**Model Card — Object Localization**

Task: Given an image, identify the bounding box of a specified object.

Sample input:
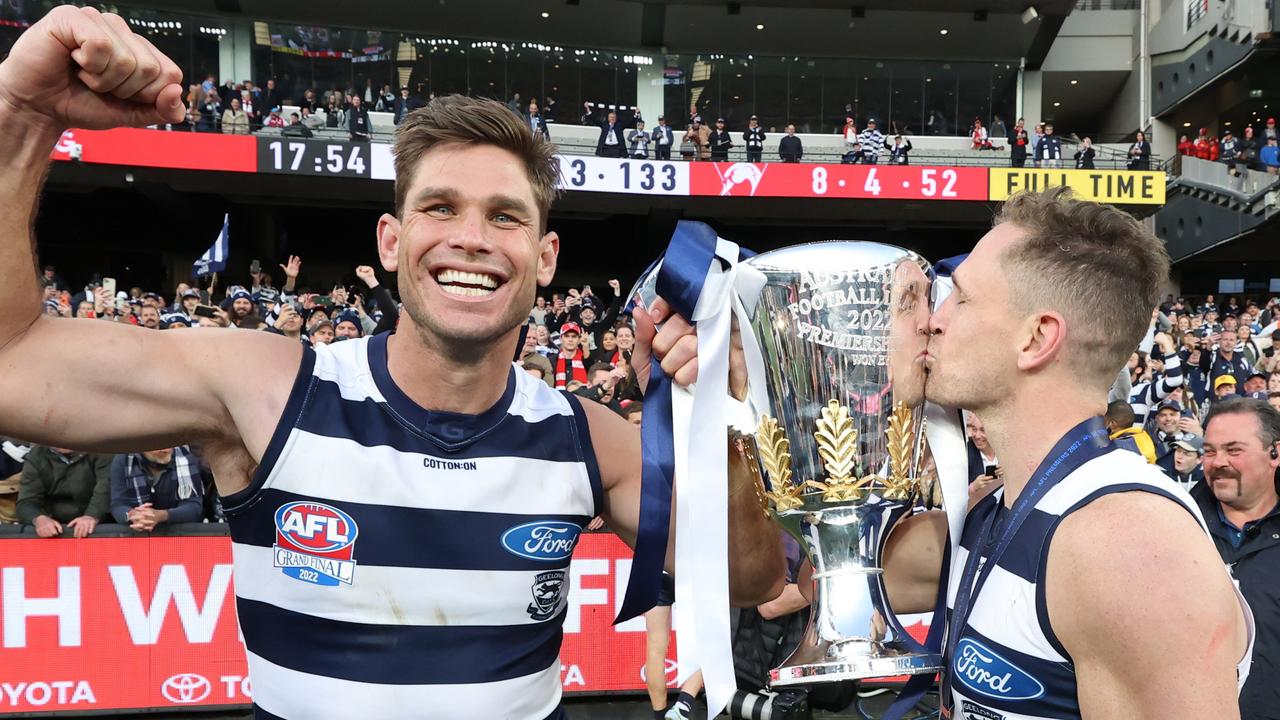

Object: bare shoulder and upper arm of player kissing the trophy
[1046,492,1245,720]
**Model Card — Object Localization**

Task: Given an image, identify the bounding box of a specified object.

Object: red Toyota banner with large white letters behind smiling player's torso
[0,534,675,714]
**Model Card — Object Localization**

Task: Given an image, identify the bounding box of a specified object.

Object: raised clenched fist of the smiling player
[0,5,186,132]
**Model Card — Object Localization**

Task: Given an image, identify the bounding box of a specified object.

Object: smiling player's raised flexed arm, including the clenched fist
[0,5,301,497]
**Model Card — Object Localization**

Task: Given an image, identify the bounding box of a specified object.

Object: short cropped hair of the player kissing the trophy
[995,187,1169,387]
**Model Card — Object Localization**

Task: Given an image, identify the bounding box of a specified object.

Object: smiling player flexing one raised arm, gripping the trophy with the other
[0,5,783,720]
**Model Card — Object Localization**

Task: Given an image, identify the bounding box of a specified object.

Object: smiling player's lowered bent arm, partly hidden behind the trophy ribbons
[582,401,786,607]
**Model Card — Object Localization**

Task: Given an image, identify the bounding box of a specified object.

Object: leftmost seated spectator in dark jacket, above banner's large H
[18,446,111,538]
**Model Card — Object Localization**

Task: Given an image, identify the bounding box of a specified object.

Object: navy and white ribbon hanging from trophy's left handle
[618,222,767,715]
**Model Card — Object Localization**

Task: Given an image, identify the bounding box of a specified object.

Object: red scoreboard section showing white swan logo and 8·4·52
[689,163,987,201]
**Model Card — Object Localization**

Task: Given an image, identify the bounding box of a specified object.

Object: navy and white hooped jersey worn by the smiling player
[223,334,600,720]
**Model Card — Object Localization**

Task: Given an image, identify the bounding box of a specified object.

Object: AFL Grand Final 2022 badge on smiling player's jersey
[271,501,360,585]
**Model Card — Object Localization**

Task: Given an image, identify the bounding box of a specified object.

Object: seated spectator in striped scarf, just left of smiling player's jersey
[110,446,207,533]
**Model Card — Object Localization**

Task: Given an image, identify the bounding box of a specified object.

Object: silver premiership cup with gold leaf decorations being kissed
[731,242,942,687]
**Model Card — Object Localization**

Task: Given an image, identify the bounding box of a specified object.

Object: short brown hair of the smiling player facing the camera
[392,95,559,231]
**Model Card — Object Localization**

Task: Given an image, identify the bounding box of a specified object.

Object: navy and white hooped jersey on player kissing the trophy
[947,450,1253,720]
